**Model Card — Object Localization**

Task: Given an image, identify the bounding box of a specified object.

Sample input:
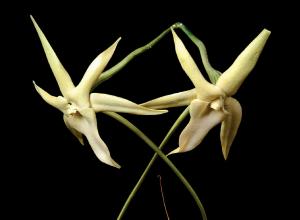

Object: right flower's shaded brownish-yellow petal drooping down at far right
[220,97,242,160]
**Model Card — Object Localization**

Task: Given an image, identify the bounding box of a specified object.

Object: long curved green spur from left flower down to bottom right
[104,112,207,220]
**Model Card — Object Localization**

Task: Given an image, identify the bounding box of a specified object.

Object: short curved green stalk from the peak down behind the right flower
[178,24,221,84]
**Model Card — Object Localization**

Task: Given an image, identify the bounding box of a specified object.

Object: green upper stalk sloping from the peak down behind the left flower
[94,23,181,88]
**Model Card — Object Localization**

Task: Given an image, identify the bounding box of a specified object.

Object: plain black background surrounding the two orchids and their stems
[1,1,294,220]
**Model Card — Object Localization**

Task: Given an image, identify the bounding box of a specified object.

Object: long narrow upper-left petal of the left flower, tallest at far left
[30,15,74,96]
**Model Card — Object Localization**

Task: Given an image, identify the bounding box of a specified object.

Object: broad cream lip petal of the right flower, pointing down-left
[169,99,224,154]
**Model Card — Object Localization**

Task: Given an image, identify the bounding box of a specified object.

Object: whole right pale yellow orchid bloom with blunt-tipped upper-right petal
[142,29,271,159]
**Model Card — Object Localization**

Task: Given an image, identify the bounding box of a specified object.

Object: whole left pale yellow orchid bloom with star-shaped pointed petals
[31,16,167,168]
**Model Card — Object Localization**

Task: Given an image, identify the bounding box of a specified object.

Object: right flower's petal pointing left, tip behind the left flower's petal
[141,89,197,109]
